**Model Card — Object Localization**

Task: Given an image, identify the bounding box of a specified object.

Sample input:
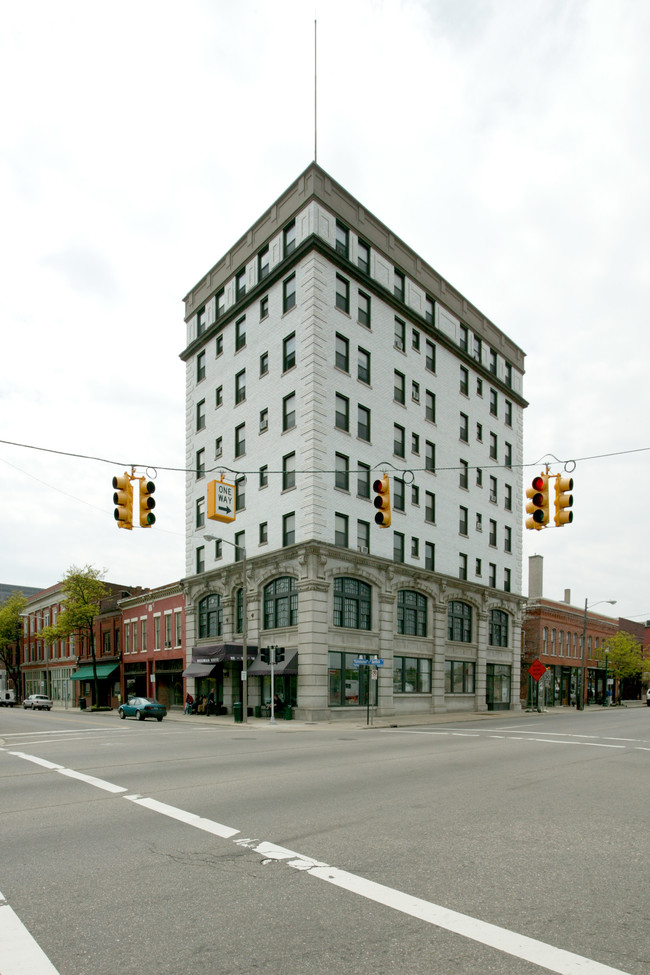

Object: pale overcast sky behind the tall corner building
[0,0,650,619]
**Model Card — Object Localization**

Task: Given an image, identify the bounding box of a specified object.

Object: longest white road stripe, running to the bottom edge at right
[308,866,627,975]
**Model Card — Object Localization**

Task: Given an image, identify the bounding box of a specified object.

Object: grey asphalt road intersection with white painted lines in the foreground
[0,708,650,975]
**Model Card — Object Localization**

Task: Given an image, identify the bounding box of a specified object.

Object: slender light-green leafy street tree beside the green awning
[40,565,110,705]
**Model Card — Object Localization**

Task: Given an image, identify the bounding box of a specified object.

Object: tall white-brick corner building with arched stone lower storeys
[181,164,526,720]
